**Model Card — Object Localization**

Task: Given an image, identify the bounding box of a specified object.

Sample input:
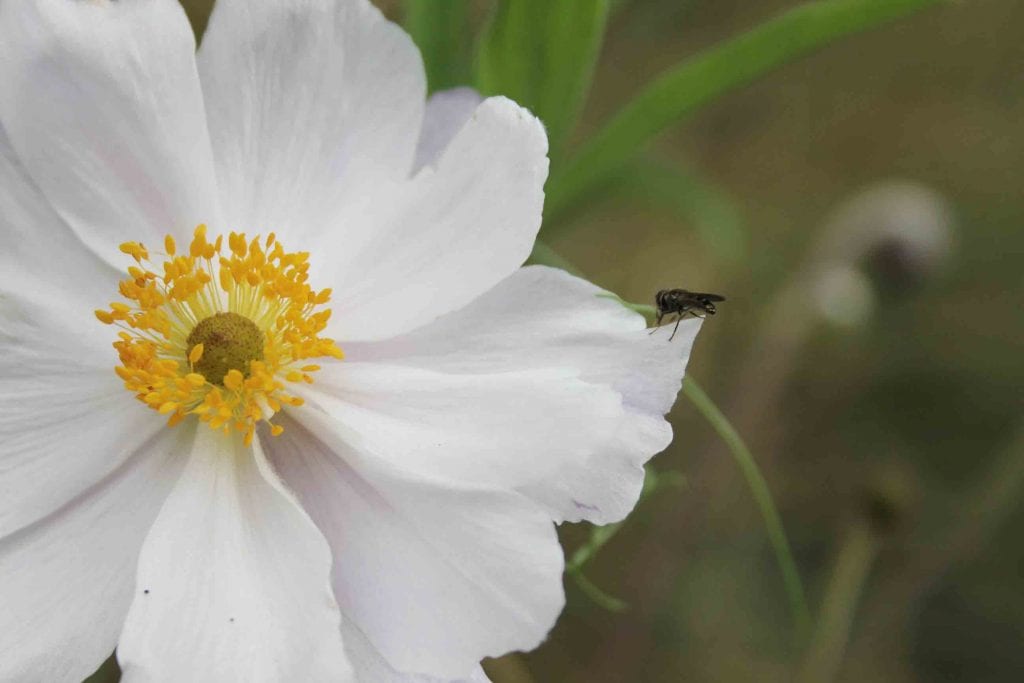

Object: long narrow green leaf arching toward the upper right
[545,0,944,227]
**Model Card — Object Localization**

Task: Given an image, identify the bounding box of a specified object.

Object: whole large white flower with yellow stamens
[0,0,698,683]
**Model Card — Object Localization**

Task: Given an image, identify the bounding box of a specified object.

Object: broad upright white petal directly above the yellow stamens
[199,0,426,242]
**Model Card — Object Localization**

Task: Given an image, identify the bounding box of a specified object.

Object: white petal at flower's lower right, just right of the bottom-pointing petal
[266,409,564,680]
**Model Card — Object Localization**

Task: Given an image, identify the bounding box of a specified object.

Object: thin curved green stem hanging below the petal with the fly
[683,377,811,639]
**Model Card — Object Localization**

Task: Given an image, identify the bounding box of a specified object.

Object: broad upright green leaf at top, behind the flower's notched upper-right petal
[476,0,608,155]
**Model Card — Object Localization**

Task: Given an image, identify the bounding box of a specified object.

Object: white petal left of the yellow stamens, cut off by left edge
[0,148,163,536]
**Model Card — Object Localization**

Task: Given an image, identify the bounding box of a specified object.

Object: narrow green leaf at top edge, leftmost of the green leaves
[402,0,470,92]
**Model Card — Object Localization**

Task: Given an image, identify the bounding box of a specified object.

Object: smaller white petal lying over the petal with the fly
[295,361,624,497]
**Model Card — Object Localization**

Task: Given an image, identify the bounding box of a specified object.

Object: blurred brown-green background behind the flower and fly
[90,0,1024,683]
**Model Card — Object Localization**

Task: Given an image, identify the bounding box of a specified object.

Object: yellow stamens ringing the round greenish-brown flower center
[96,225,343,443]
